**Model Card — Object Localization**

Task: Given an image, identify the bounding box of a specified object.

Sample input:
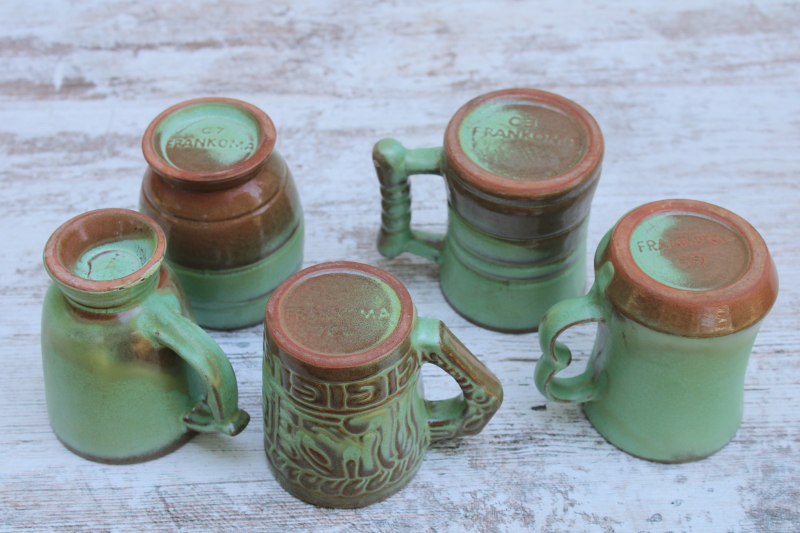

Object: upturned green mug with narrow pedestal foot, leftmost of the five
[42,209,250,463]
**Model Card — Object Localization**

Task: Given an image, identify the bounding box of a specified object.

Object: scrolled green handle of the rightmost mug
[534,262,614,403]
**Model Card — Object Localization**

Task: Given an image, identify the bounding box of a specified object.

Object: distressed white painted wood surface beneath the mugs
[0,0,800,533]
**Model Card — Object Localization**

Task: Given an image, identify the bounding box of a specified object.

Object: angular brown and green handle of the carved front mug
[413,318,503,441]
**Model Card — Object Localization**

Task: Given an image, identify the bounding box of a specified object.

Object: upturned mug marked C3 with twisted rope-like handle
[373,89,603,332]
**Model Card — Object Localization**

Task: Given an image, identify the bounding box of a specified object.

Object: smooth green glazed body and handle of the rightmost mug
[535,227,761,463]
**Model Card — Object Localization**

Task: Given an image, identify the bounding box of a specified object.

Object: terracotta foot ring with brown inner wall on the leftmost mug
[44,208,167,293]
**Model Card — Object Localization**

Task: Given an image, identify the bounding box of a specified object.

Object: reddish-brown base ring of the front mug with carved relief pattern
[264,261,415,382]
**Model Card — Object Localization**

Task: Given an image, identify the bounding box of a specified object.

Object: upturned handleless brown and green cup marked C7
[139,98,303,329]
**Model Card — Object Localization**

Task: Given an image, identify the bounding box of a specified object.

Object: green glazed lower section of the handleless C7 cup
[167,219,304,329]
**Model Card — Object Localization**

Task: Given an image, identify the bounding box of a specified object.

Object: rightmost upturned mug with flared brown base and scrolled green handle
[535,200,778,463]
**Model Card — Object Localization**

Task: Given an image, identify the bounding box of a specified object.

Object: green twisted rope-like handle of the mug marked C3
[372,139,444,263]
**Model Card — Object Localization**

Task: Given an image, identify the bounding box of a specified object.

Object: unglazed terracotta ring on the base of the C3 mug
[444,88,603,198]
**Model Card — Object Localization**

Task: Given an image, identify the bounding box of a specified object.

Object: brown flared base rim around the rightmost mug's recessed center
[600,199,778,337]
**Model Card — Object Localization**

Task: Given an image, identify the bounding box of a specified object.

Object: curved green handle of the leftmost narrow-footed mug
[139,293,250,437]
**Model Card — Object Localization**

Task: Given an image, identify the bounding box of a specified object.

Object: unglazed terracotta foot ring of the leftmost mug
[44,208,167,293]
